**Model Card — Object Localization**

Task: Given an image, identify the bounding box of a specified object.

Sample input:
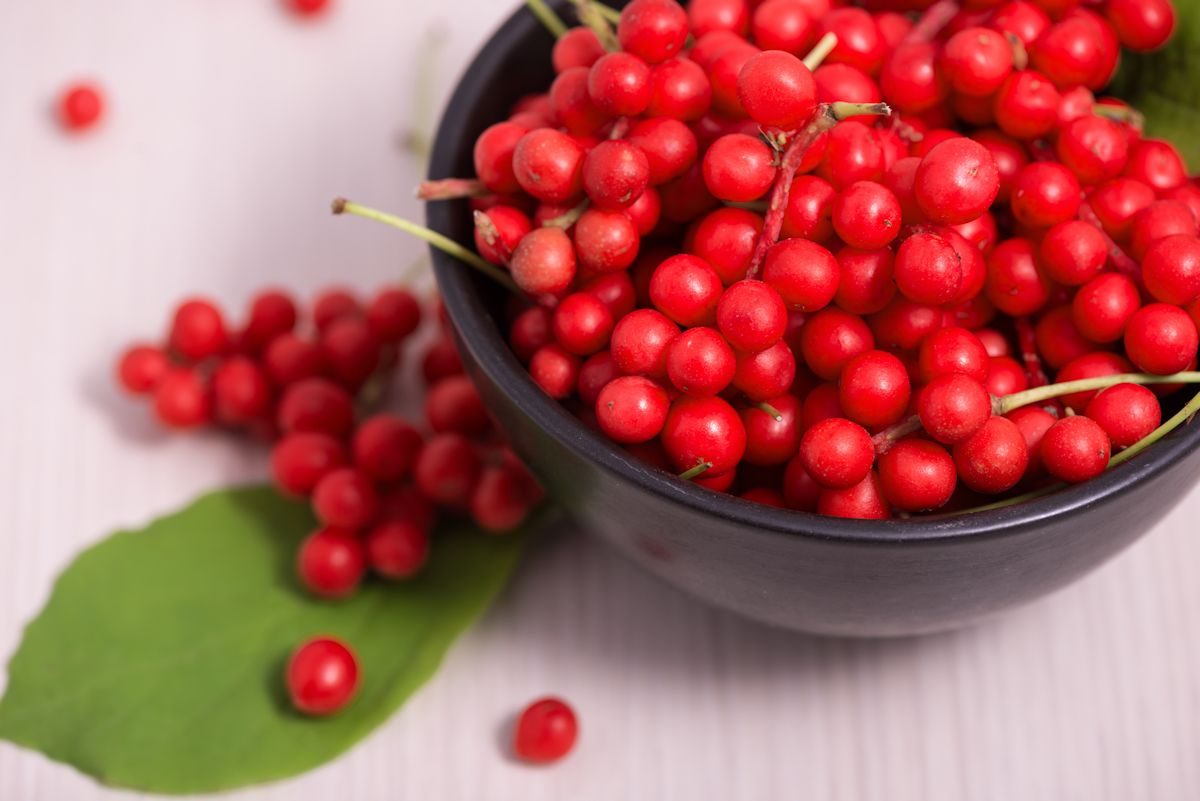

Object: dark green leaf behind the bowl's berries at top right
[1112,0,1200,171]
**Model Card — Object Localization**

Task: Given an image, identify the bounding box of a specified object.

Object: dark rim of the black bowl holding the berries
[426,4,1200,544]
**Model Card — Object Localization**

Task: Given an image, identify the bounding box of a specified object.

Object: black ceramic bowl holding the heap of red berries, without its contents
[428,3,1200,637]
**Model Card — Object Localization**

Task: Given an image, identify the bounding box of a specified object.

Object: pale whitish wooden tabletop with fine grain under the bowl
[0,0,1200,801]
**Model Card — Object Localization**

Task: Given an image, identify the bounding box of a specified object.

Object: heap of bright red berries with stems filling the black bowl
[335,0,1200,519]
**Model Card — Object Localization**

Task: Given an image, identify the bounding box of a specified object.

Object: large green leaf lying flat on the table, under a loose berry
[0,487,535,793]
